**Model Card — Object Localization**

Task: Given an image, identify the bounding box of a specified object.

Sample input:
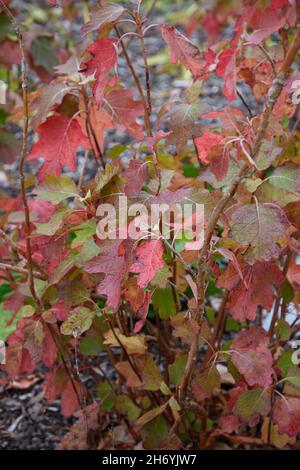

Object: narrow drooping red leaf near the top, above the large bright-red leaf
[84,38,118,105]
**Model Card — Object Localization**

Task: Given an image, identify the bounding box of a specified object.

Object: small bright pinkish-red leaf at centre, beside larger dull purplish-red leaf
[130,240,164,288]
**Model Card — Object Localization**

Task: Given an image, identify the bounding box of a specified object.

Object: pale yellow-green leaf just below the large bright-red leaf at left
[34,175,79,204]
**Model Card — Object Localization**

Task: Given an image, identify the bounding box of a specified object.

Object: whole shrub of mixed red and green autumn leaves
[0,0,300,449]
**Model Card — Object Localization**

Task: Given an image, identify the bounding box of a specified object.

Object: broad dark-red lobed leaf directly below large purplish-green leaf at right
[217,261,284,321]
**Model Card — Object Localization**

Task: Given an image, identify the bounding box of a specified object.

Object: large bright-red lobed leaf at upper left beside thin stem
[28,114,89,179]
